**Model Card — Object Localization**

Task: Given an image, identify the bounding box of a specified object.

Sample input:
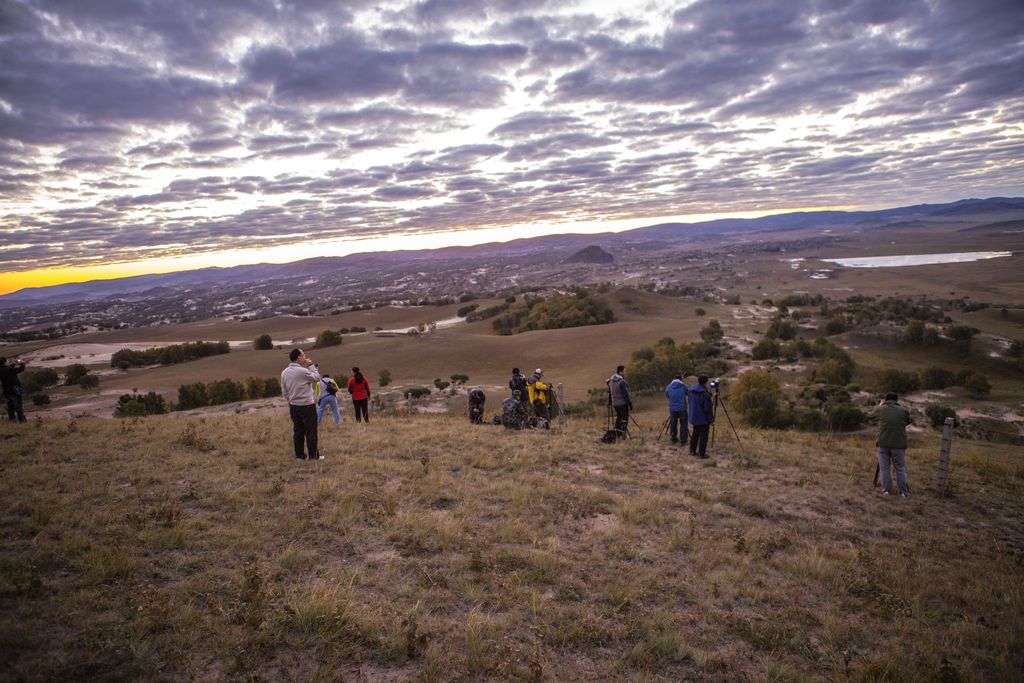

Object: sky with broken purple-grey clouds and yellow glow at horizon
[0,0,1024,291]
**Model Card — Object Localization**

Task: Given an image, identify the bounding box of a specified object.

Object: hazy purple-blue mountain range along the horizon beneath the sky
[0,197,1024,308]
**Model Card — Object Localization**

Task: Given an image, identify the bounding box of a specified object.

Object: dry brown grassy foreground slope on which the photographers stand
[0,409,1024,681]
